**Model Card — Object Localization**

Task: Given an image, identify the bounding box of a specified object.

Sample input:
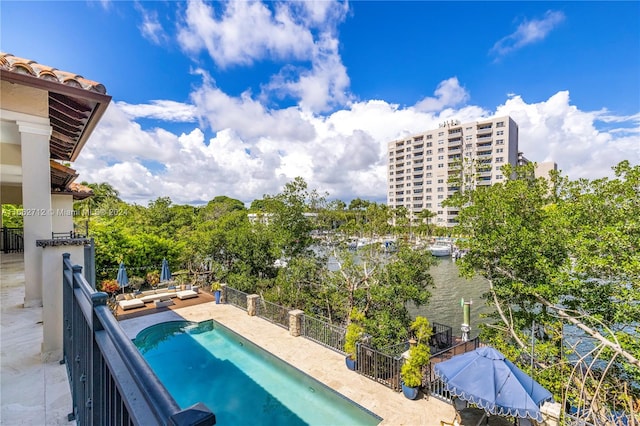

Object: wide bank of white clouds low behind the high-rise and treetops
[74,79,640,204]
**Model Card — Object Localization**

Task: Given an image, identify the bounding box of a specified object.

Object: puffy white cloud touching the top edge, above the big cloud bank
[178,0,350,112]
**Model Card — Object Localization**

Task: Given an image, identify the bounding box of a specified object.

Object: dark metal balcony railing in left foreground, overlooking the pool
[62,253,216,426]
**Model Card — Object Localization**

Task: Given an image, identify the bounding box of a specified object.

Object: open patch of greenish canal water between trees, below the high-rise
[409,257,493,337]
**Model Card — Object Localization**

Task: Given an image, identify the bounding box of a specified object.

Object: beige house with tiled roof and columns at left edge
[0,52,111,359]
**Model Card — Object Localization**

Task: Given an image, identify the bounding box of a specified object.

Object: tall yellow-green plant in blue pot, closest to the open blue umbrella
[400,316,432,399]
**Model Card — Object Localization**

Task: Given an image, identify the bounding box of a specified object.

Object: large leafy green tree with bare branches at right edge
[448,162,640,424]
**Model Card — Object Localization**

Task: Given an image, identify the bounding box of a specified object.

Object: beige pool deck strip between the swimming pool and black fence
[120,303,455,426]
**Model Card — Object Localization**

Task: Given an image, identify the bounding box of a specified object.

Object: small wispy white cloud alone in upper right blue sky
[489,10,565,57]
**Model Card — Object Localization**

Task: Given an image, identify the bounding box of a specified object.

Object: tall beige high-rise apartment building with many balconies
[387,116,518,226]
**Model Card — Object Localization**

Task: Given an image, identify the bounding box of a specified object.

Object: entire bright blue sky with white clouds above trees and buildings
[0,1,640,204]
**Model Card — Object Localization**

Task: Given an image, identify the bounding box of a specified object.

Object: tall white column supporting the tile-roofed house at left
[16,121,52,307]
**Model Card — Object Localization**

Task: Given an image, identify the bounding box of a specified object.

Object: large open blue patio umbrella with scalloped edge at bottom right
[435,347,553,421]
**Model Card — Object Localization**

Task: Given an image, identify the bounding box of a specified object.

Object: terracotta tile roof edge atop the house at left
[0,52,107,95]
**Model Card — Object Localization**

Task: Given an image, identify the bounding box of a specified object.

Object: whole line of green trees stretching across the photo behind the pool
[3,161,640,424]
